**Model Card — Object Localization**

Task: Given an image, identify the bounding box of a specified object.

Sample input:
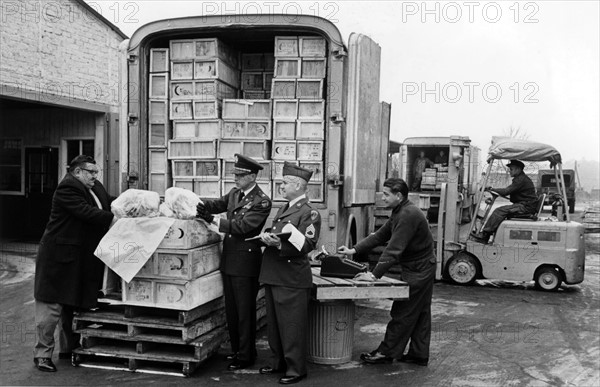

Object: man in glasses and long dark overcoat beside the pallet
[34,155,114,372]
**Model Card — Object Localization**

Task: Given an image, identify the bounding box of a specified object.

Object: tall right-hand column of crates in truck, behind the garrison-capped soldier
[271,36,327,202]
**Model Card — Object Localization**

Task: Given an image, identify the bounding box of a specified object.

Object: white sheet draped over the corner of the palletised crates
[94,217,175,282]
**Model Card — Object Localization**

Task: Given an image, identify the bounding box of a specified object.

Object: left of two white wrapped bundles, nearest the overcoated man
[110,189,160,218]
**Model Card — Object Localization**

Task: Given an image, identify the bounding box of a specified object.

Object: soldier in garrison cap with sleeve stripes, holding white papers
[259,162,321,384]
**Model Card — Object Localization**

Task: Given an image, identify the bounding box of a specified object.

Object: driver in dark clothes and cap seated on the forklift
[473,160,538,243]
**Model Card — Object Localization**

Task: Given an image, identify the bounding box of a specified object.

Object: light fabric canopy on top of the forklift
[487,137,562,167]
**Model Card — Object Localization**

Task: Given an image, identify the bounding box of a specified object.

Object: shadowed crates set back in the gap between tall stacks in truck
[241,52,275,99]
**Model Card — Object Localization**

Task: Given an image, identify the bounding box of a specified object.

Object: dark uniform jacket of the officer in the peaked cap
[204,184,271,277]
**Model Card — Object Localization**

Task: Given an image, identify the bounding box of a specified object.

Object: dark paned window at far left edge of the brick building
[0,138,25,195]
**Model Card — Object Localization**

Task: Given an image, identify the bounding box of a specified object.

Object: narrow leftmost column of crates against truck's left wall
[148,48,171,195]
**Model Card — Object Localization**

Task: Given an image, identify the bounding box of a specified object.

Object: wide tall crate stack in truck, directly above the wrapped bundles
[168,38,240,198]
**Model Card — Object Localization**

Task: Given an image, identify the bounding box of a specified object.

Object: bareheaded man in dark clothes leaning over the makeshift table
[338,179,436,366]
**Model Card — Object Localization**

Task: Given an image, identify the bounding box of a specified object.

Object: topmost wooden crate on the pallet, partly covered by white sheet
[158,219,221,249]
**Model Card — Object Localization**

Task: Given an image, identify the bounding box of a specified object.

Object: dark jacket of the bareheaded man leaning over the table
[354,199,435,278]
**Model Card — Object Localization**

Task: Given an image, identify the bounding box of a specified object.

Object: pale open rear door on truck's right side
[344,33,380,207]
